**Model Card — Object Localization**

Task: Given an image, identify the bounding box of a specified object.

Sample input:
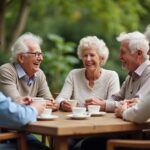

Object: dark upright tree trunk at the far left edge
[0,0,7,50]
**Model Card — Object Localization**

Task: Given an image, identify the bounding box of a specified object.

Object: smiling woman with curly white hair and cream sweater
[56,36,120,112]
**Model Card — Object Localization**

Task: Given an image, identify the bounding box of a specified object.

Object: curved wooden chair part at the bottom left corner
[0,132,27,150]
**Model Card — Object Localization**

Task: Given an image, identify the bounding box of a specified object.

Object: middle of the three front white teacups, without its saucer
[72,107,86,116]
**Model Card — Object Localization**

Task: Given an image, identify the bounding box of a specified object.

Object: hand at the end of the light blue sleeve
[30,101,46,115]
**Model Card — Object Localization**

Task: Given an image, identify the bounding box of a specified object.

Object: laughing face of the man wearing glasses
[17,41,43,77]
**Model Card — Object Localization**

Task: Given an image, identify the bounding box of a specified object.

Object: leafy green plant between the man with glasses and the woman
[41,34,78,92]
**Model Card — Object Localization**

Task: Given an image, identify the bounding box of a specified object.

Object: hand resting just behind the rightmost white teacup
[85,98,106,111]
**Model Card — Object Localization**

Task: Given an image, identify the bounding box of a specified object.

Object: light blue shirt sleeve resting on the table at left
[0,92,38,129]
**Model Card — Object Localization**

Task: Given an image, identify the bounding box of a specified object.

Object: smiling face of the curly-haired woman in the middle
[82,48,102,71]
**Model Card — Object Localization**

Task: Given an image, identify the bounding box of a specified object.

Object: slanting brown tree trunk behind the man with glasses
[7,0,32,50]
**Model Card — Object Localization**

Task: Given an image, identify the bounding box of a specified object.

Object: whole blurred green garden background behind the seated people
[0,0,150,92]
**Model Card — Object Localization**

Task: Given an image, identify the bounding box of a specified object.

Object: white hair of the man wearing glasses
[10,32,42,62]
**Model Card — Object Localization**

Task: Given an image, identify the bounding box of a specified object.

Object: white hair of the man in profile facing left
[117,31,149,60]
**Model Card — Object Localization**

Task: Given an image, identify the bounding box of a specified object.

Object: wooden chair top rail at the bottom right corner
[107,139,150,150]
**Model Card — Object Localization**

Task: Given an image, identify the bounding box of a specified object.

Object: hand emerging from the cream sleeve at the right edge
[115,102,127,118]
